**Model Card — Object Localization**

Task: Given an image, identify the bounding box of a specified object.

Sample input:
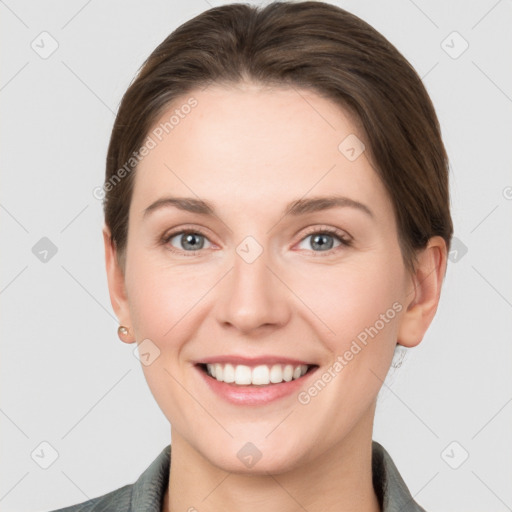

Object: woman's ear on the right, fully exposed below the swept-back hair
[398,236,447,347]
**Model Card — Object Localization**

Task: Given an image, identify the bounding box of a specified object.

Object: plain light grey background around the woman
[0,0,512,512]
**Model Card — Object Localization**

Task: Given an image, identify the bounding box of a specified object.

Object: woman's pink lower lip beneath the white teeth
[196,366,318,405]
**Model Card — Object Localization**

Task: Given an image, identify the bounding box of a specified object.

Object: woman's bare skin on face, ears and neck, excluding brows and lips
[104,83,446,512]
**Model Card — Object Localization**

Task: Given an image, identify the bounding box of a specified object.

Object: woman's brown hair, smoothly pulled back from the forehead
[104,1,453,268]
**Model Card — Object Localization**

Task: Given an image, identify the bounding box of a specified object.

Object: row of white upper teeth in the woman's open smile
[206,363,308,386]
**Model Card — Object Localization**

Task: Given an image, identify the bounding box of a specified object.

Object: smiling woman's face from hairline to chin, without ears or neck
[108,84,413,472]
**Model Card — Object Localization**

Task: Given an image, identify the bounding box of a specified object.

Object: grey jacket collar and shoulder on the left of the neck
[46,445,171,512]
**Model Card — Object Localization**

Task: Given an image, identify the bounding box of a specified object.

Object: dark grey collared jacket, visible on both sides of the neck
[48,441,426,512]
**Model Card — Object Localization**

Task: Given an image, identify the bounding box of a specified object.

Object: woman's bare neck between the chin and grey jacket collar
[163,416,381,512]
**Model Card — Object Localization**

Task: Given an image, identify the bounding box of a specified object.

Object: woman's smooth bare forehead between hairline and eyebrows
[132,84,387,218]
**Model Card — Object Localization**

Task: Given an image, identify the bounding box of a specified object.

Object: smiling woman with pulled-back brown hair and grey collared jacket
[52,2,452,512]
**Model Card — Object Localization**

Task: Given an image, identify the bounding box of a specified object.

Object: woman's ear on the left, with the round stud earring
[103,226,135,343]
